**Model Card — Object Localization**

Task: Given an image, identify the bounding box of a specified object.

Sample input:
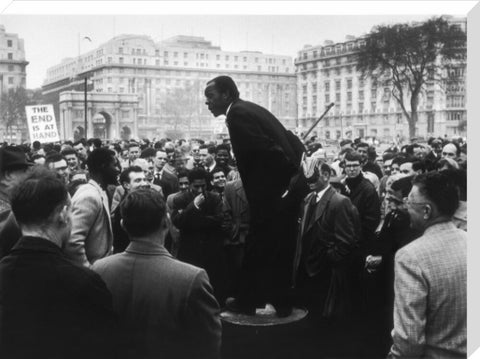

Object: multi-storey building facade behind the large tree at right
[295,18,466,141]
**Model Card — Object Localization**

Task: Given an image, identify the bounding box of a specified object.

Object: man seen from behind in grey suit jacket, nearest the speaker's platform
[93,189,221,359]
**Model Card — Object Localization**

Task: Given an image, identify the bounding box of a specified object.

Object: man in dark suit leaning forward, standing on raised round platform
[205,76,301,316]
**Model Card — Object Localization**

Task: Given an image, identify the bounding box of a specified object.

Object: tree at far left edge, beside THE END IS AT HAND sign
[0,87,28,142]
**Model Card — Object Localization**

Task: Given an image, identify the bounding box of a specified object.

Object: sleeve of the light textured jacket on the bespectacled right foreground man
[388,250,428,358]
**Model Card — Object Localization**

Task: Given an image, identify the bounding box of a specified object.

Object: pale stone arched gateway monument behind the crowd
[59,91,138,140]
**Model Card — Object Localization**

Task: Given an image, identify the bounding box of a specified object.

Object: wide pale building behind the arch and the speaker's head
[42,35,297,138]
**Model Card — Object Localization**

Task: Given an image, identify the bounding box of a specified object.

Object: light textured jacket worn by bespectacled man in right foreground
[389,222,467,358]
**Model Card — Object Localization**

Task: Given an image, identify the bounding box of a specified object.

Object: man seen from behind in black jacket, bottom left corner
[0,168,116,359]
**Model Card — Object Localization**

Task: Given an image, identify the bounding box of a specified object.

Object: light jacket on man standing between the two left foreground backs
[64,179,113,267]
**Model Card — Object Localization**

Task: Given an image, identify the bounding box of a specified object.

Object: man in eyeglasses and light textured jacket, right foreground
[388,172,467,358]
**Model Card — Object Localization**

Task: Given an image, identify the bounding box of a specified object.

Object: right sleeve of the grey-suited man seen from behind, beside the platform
[185,270,222,358]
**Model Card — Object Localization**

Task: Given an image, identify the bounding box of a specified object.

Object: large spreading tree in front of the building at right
[357,17,466,138]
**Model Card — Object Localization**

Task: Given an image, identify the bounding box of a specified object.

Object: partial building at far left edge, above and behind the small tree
[0,24,28,141]
